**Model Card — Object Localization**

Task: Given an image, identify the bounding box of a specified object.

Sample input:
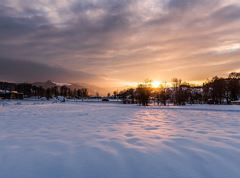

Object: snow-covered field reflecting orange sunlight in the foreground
[0,101,240,178]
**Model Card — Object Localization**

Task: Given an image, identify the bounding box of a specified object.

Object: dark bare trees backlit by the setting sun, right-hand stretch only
[114,72,240,106]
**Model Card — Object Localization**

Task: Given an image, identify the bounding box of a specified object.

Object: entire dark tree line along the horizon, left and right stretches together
[0,72,240,106]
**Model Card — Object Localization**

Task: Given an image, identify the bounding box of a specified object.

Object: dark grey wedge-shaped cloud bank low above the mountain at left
[0,58,98,82]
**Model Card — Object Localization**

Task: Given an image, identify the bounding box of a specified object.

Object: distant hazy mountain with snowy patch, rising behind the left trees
[33,80,107,95]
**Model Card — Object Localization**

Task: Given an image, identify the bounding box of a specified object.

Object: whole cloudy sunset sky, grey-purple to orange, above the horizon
[0,0,240,86]
